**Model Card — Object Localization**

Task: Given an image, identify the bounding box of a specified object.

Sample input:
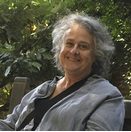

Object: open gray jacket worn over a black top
[0,75,125,131]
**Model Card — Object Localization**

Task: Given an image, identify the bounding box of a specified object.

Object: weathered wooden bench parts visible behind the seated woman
[9,77,131,131]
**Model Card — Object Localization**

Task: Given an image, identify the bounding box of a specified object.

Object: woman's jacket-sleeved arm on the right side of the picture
[86,96,125,131]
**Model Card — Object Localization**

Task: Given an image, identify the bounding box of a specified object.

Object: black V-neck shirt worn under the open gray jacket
[32,78,87,130]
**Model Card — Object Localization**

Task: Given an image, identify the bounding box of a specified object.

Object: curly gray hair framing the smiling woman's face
[52,13,115,77]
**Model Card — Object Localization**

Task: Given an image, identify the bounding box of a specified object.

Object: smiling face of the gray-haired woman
[59,23,95,75]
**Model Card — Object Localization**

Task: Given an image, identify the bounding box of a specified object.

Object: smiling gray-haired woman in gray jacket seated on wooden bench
[0,14,124,131]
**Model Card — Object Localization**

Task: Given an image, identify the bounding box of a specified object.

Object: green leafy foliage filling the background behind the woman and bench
[0,0,131,116]
